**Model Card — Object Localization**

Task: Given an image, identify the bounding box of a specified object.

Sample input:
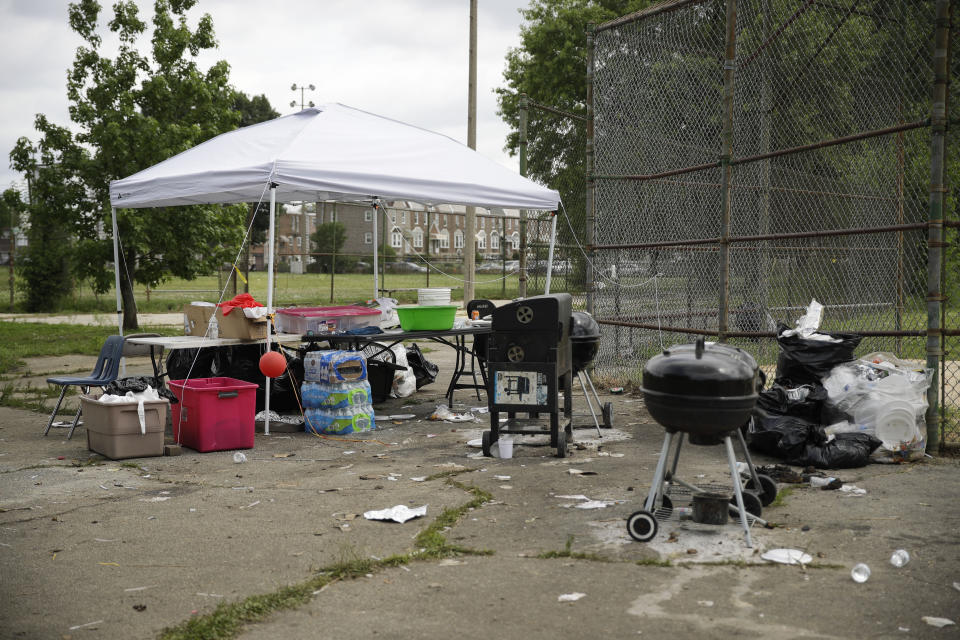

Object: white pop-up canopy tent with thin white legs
[110,103,560,433]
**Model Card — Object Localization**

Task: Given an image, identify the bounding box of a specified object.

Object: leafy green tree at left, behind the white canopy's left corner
[11,0,246,329]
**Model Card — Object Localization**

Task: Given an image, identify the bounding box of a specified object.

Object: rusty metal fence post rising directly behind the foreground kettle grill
[717,0,737,342]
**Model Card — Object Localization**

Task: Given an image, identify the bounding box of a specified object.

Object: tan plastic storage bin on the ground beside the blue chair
[80,395,170,460]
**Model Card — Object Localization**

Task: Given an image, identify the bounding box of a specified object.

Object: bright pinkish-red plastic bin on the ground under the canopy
[169,378,257,452]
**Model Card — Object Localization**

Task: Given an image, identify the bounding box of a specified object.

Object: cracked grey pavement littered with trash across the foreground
[0,345,960,640]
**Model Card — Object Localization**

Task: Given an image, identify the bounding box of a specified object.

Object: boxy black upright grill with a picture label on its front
[481,293,573,458]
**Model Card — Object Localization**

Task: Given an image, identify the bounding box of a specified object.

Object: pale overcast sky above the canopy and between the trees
[0,0,528,190]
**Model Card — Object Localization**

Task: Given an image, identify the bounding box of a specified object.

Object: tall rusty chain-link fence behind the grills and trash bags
[586,0,960,449]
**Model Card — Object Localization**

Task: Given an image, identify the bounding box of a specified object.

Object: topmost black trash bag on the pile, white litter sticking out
[775,324,863,387]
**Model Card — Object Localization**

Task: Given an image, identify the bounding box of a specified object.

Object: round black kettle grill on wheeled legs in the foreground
[627,338,777,547]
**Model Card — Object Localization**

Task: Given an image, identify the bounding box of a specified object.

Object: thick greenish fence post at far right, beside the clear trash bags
[927,0,951,450]
